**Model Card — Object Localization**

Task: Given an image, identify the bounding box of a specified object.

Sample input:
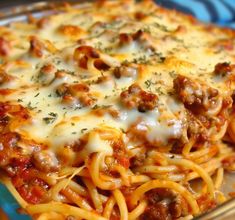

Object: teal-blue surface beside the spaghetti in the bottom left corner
[0,184,30,220]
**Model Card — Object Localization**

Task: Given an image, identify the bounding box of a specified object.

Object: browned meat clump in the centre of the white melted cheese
[120,84,158,112]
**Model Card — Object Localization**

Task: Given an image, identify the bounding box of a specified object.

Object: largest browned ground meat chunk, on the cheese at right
[173,75,219,110]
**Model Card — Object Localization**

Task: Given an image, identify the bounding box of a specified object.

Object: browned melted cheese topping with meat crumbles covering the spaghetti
[0,0,235,217]
